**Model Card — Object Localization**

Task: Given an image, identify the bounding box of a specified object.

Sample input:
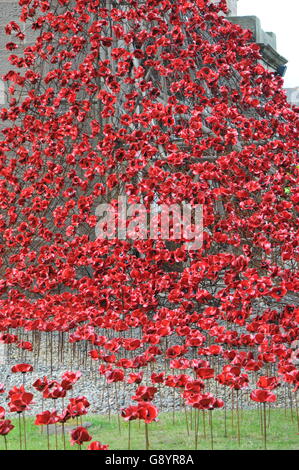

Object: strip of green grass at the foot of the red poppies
[0,409,299,450]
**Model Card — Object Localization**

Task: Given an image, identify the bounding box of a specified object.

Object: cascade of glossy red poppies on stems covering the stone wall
[0,0,299,449]
